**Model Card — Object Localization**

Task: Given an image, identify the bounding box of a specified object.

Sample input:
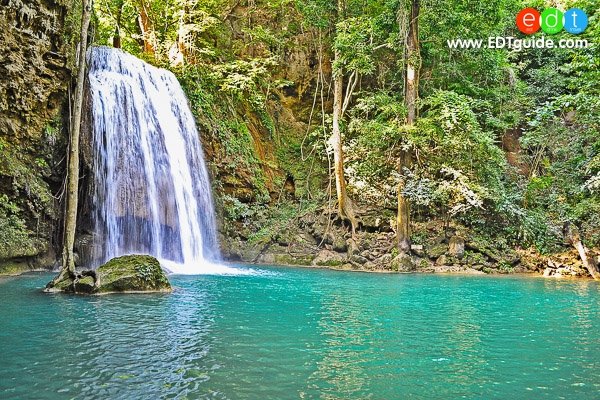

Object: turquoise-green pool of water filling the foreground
[0,268,600,399]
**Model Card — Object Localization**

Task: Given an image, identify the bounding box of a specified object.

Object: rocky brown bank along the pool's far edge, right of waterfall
[220,208,590,277]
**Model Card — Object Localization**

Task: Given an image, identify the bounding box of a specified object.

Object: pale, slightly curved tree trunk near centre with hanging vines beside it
[331,0,356,235]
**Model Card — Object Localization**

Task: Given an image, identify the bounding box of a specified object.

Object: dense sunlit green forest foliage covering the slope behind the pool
[88,0,600,258]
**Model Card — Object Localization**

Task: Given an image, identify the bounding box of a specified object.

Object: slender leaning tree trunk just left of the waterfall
[50,0,92,286]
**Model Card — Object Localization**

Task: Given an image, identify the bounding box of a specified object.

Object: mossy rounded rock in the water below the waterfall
[46,255,172,294]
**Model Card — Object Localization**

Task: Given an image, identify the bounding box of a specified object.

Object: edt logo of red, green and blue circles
[517,8,587,35]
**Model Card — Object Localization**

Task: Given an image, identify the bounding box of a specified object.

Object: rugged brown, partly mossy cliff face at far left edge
[0,0,70,272]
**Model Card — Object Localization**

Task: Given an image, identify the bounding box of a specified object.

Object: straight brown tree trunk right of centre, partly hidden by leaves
[396,0,421,253]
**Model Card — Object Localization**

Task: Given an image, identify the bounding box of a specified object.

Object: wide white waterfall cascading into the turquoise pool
[88,47,219,273]
